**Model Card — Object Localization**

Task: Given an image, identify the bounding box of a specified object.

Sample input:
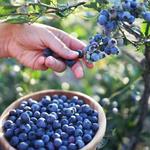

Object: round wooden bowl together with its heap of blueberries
[0,90,106,150]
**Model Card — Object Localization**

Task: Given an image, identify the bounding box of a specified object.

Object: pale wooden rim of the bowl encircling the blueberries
[0,89,106,150]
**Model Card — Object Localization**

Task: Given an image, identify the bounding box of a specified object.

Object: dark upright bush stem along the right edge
[128,45,150,150]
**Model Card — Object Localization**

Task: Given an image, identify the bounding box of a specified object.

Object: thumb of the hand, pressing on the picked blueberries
[42,31,78,59]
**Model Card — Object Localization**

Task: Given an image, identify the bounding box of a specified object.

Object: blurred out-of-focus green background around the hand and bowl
[0,0,150,150]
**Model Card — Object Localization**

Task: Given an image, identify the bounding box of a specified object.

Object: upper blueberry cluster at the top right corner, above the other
[98,0,150,34]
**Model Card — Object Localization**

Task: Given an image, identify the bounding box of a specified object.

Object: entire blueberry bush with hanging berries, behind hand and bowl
[0,0,150,150]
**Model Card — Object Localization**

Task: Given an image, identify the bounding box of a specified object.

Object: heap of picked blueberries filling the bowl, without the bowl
[3,95,99,150]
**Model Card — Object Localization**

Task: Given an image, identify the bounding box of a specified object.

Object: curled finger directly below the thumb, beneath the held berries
[45,56,66,72]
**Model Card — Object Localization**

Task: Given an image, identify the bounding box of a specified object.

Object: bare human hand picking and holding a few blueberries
[0,24,92,78]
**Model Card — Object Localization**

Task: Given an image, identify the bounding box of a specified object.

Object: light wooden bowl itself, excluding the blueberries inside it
[0,90,106,150]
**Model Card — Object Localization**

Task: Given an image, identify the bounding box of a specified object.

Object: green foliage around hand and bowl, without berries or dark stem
[0,0,150,150]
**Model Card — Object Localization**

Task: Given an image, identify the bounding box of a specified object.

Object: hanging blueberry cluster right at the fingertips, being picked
[85,34,119,62]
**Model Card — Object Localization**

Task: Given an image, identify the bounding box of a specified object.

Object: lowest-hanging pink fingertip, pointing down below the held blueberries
[71,62,84,79]
